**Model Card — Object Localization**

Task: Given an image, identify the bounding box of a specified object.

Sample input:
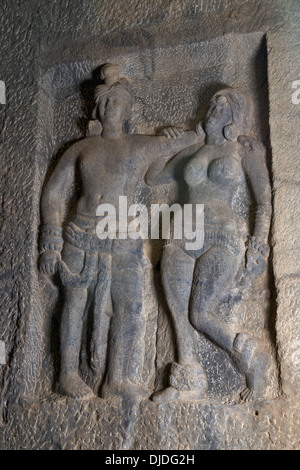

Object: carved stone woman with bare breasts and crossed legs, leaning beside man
[146,88,271,401]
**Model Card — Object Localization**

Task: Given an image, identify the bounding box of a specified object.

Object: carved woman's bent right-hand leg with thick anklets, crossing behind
[190,247,272,400]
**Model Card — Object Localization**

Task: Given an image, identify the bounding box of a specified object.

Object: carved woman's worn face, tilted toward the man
[205,94,232,136]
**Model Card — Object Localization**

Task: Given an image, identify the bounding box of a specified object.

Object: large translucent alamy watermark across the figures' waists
[96,196,204,250]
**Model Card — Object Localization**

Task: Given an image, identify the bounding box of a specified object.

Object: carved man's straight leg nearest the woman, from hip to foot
[102,253,146,398]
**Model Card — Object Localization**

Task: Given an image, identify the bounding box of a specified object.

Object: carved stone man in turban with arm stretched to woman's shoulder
[40,66,199,398]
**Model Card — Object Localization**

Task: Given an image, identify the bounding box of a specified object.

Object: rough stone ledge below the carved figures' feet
[0,399,300,450]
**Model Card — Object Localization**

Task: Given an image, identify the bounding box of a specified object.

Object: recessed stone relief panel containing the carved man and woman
[26,33,278,403]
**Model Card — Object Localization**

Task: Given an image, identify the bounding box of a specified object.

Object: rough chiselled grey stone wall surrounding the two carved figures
[0,0,300,449]
